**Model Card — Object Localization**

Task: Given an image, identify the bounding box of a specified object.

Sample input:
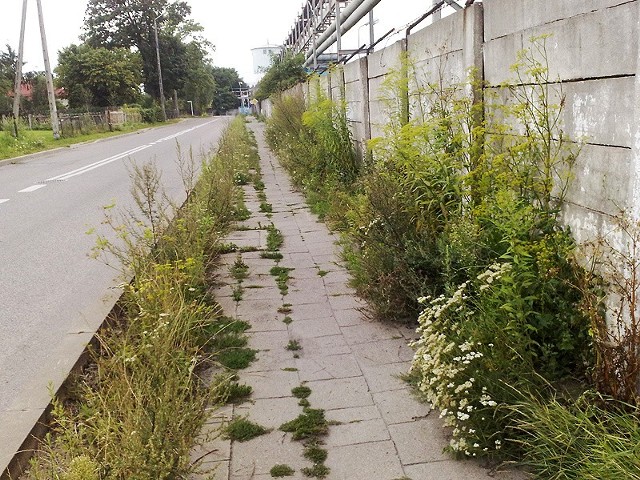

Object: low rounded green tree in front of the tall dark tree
[56,44,142,108]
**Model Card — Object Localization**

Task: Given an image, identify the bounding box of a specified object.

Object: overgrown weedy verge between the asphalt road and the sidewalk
[26,119,254,480]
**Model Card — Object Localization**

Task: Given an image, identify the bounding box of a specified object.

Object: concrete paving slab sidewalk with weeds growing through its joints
[188,123,526,480]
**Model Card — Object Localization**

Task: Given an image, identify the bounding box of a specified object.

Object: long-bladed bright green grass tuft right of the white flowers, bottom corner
[513,392,640,480]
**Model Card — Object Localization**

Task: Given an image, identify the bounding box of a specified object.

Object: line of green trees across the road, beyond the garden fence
[0,0,242,119]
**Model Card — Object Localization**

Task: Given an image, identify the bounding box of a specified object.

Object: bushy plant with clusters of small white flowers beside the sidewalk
[412,263,511,457]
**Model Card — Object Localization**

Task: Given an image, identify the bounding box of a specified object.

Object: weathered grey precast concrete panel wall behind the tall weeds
[261,0,640,246]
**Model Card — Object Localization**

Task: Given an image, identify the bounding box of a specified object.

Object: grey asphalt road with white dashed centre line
[0,117,228,473]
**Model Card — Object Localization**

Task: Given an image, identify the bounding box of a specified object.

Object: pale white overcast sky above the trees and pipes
[0,0,450,84]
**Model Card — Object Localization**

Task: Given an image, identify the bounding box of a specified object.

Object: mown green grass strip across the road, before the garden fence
[0,124,149,160]
